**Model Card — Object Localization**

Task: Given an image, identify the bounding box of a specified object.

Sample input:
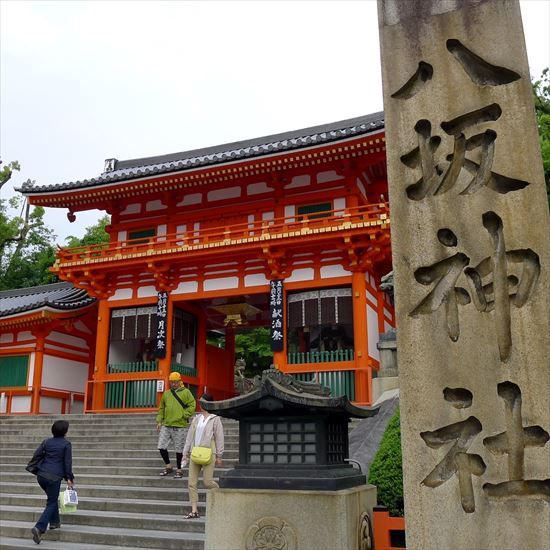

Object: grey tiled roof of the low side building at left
[0,283,95,318]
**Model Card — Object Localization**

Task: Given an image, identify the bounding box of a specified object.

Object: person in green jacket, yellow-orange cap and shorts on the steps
[156,372,197,478]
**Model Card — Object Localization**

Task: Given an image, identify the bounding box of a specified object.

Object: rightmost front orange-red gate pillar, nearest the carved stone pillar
[351,271,372,404]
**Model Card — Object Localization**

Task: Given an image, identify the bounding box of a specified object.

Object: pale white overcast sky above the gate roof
[0,0,550,244]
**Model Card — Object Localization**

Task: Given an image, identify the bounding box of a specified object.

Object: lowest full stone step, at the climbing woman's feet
[0,519,205,550]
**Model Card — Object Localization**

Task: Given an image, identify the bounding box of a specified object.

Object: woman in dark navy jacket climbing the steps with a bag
[31,420,74,544]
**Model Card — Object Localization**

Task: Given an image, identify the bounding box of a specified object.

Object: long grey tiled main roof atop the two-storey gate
[17,112,384,195]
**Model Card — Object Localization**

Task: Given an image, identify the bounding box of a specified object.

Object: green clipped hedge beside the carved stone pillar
[369,409,404,516]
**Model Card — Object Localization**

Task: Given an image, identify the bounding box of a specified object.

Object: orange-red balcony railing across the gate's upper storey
[55,203,389,266]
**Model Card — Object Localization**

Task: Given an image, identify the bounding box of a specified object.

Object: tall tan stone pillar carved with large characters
[378,0,550,550]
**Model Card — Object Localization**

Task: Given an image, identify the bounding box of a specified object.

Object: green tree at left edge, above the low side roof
[0,161,57,290]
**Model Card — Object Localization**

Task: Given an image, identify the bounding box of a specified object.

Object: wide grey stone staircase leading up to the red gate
[0,413,238,550]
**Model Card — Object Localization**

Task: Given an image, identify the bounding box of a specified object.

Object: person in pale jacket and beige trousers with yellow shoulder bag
[182,393,224,519]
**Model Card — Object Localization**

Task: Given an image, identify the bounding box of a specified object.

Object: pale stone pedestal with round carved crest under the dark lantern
[205,485,376,550]
